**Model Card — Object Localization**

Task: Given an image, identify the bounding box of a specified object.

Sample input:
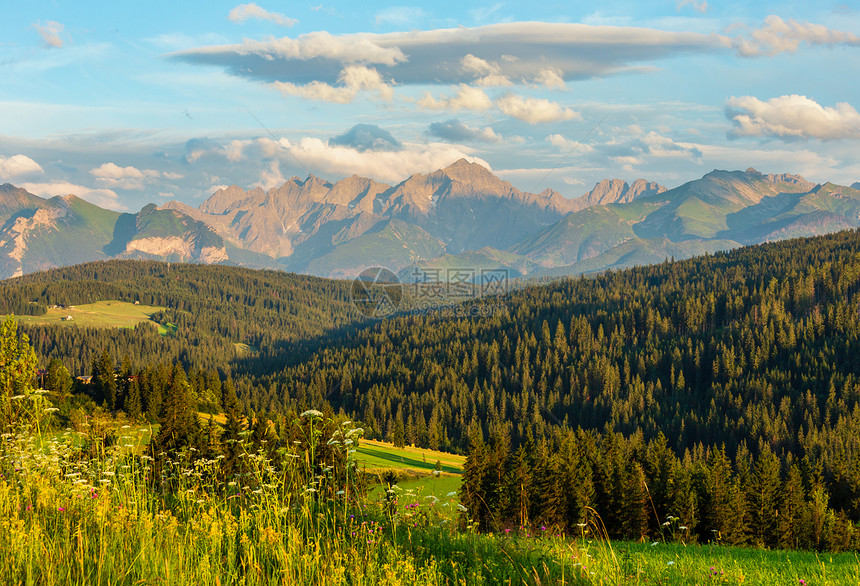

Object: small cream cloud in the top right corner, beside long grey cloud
[731,15,860,57]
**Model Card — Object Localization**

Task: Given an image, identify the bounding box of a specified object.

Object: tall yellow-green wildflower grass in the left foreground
[0,414,580,585]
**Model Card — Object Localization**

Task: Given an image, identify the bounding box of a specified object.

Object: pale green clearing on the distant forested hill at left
[15,301,167,334]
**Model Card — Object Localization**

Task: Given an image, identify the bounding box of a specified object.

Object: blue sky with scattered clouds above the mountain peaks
[0,0,860,211]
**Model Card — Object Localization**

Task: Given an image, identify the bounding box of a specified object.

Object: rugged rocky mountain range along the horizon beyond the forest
[0,159,860,279]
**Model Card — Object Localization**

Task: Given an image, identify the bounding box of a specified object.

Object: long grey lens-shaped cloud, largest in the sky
[171,22,730,86]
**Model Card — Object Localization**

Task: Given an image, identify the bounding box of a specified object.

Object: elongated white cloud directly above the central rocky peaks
[276,138,490,183]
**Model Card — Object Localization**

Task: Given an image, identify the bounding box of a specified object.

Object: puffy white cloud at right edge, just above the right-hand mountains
[726,95,860,140]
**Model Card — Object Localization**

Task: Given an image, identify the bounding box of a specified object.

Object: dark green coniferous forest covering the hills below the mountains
[0,231,860,550]
